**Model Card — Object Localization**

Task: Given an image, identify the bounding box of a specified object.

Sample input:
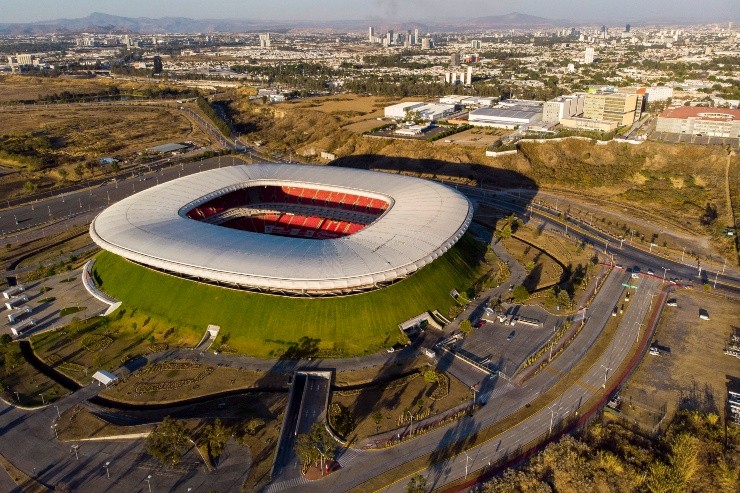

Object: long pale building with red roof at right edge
[655,106,740,138]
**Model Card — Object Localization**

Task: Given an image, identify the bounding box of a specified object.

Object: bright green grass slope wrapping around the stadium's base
[95,236,483,357]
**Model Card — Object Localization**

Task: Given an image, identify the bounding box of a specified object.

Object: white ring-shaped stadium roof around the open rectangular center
[90,164,473,295]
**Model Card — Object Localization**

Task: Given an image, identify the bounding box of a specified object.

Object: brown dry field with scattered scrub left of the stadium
[0,105,209,196]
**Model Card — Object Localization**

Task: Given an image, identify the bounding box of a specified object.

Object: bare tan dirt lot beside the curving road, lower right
[621,289,740,427]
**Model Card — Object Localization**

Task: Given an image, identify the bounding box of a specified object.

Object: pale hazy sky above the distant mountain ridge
[0,0,740,23]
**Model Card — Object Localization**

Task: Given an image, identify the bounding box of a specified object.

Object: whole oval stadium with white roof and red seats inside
[90,164,473,296]
